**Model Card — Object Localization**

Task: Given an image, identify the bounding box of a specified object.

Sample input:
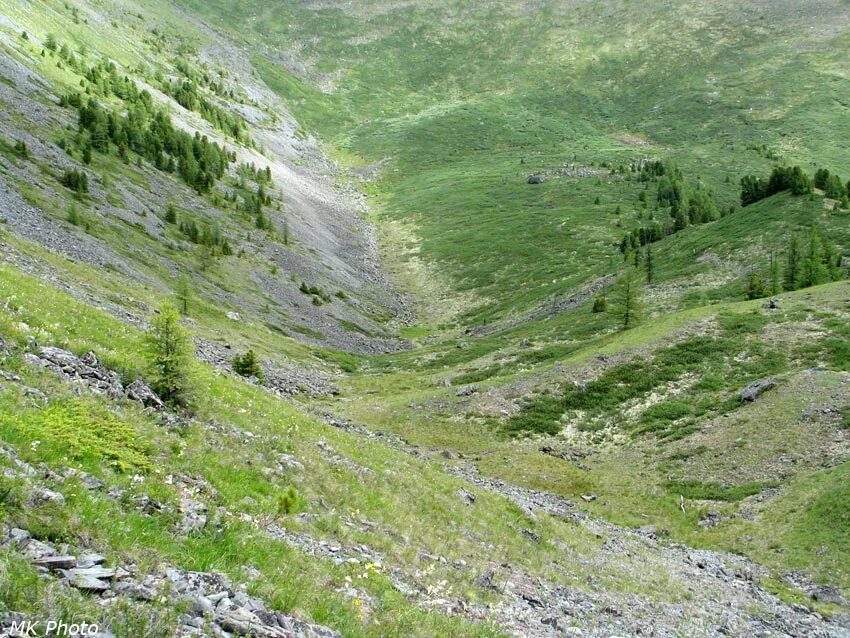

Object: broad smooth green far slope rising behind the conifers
[176,1,850,323]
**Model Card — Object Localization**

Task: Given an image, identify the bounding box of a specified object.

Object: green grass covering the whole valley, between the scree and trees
[0,0,850,638]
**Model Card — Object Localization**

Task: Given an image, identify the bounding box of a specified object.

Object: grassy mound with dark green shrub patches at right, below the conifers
[334,282,850,586]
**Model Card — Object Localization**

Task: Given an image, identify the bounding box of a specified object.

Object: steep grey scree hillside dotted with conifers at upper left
[2,2,406,360]
